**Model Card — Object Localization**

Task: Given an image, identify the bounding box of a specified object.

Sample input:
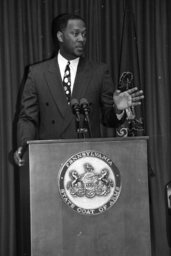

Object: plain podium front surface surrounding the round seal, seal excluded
[29,138,151,256]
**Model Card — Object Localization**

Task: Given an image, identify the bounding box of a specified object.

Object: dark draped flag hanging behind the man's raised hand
[116,6,144,137]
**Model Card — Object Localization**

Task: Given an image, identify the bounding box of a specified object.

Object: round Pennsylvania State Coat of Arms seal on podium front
[59,150,121,215]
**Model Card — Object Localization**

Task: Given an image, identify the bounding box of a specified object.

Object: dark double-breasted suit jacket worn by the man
[18,57,123,145]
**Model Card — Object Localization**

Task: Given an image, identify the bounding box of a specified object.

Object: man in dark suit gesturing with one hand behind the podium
[14,14,143,166]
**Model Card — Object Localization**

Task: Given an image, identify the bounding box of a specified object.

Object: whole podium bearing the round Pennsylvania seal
[29,137,151,256]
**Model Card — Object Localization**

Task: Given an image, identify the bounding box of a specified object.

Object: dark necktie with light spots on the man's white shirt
[63,61,71,104]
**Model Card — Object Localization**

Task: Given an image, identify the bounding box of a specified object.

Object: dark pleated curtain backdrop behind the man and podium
[0,0,171,256]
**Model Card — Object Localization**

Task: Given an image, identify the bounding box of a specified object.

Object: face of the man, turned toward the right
[60,19,86,59]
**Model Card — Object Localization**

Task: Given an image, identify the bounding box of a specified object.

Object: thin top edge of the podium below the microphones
[27,136,149,144]
